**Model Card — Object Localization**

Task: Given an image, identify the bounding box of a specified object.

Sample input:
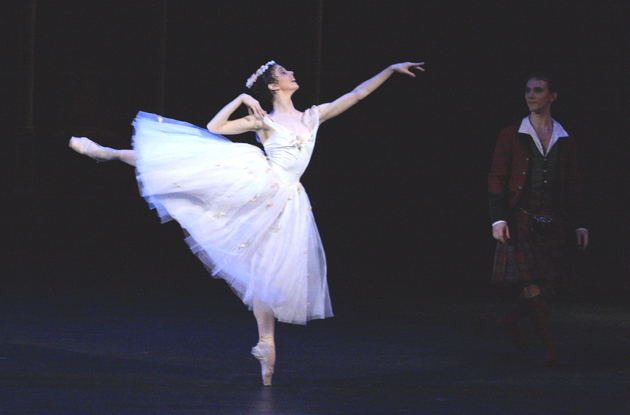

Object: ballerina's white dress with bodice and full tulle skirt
[133,108,332,324]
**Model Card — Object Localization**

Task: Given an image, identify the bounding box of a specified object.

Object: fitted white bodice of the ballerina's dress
[263,107,319,185]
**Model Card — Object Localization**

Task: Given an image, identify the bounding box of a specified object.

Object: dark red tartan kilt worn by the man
[492,210,569,294]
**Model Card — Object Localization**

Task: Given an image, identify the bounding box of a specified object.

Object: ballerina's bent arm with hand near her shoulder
[207,94,267,135]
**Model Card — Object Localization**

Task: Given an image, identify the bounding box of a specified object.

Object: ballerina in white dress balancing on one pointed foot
[70,61,424,385]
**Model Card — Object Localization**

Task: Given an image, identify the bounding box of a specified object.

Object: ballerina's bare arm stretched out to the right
[317,62,424,123]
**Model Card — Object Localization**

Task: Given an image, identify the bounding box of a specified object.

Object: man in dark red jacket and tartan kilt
[488,72,588,366]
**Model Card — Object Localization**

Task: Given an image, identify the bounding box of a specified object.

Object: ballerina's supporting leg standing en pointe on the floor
[252,299,276,386]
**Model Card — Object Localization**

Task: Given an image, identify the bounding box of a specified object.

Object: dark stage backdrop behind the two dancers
[0,0,630,301]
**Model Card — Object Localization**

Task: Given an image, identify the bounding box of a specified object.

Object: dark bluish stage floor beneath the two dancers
[0,281,630,415]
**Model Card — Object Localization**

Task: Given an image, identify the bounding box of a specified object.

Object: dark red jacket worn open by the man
[488,126,585,228]
